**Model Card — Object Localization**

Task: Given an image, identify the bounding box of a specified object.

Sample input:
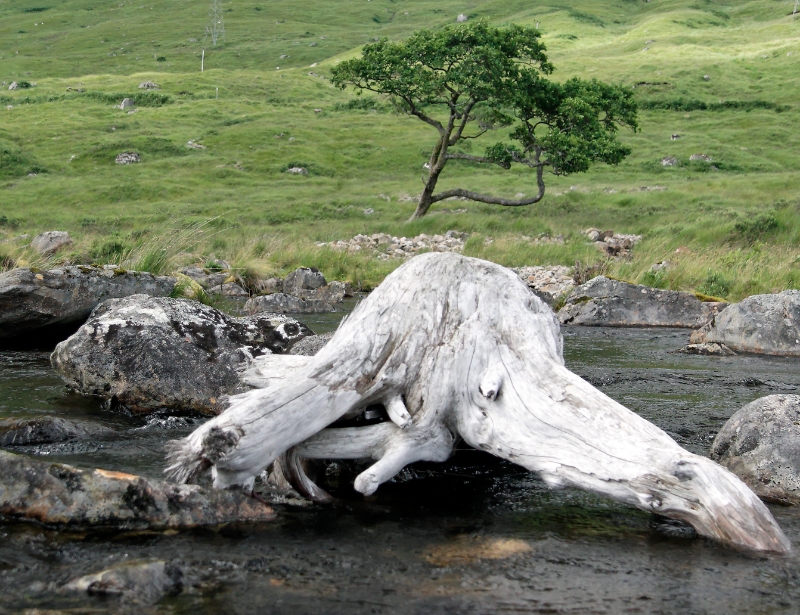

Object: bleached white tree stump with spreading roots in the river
[167,254,790,551]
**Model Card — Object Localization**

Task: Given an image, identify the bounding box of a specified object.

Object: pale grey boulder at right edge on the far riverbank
[691,290,800,357]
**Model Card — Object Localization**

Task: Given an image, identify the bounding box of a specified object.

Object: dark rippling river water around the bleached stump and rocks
[0,324,800,615]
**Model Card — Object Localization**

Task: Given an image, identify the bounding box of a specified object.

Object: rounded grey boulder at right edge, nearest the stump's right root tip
[711,395,800,502]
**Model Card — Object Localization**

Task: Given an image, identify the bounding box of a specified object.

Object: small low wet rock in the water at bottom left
[61,561,183,605]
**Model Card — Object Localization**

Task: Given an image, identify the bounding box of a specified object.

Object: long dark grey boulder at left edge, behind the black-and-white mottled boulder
[0,265,175,339]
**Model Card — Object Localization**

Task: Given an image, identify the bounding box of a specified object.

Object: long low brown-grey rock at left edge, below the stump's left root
[0,451,275,529]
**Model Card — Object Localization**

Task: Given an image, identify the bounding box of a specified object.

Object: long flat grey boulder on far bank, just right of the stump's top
[558,276,728,329]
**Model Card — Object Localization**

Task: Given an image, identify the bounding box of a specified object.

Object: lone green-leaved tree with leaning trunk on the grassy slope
[331,20,637,220]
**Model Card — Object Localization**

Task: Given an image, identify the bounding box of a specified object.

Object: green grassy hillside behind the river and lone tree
[0,0,800,299]
